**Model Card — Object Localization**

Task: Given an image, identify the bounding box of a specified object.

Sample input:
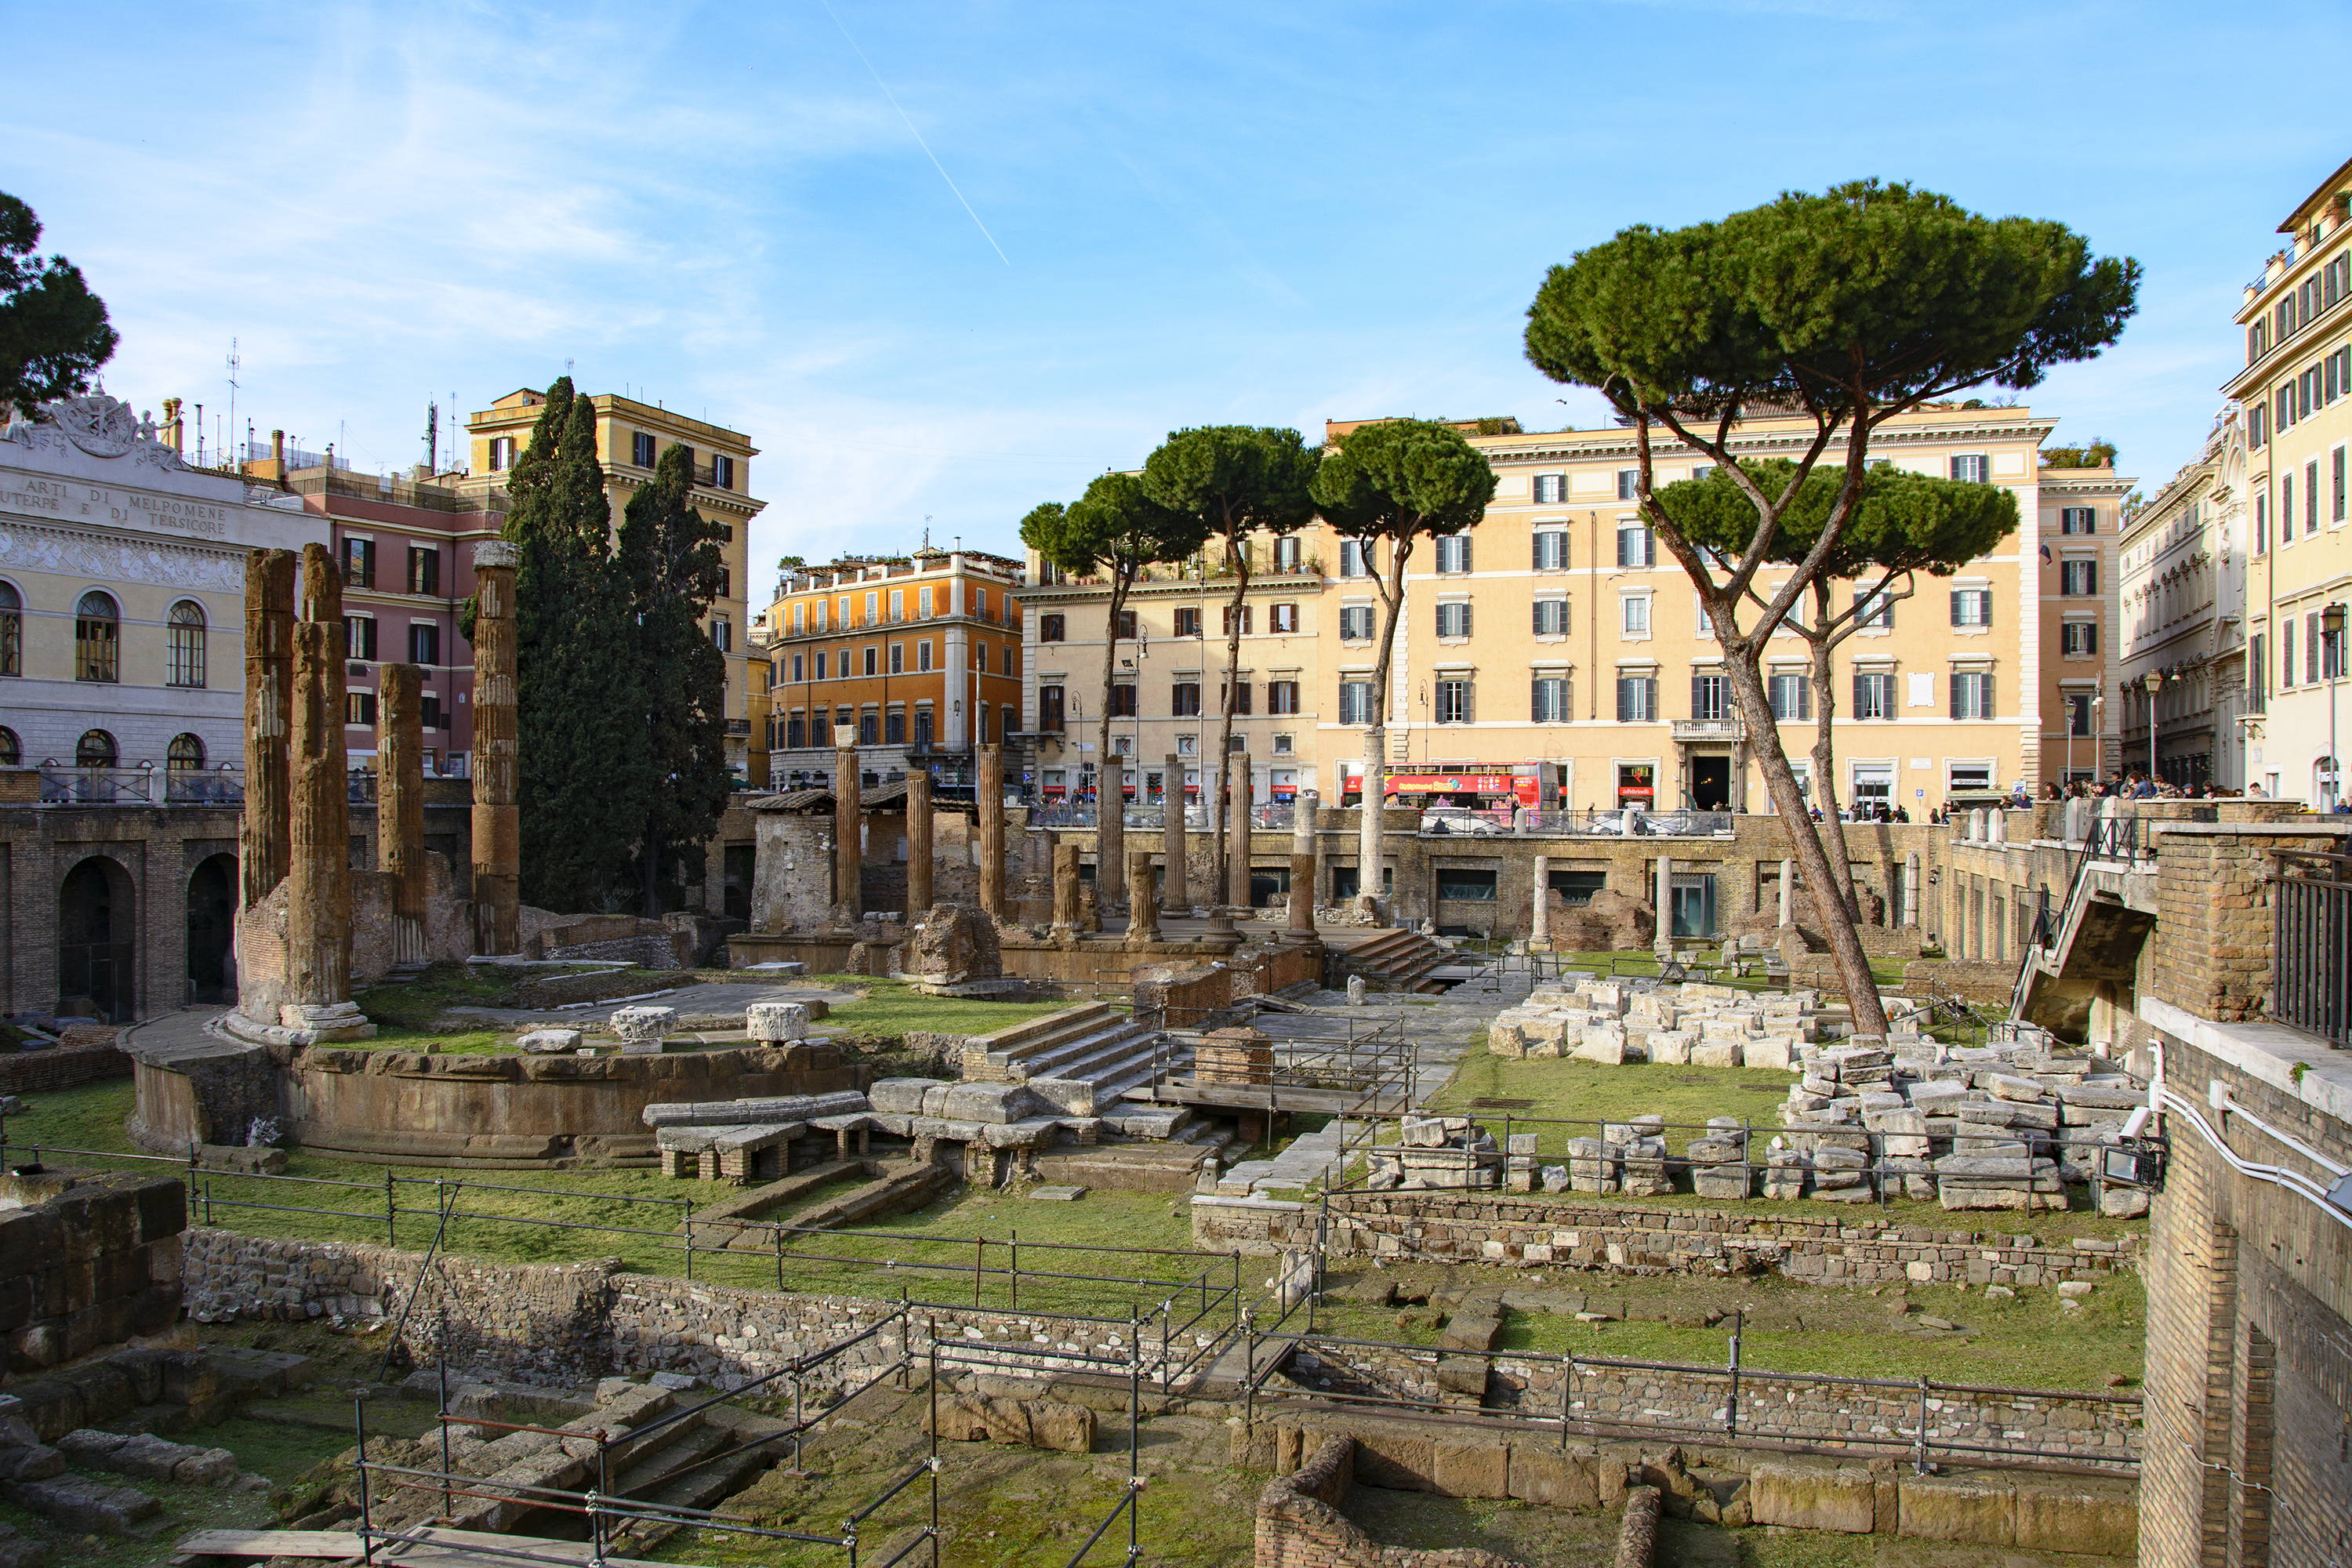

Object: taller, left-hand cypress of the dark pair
[506,376,644,912]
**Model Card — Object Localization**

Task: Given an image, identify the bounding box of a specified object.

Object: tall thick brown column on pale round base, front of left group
[278,546,367,1034]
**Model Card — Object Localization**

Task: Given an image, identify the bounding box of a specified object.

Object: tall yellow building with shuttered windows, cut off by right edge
[2223,162,2352,811]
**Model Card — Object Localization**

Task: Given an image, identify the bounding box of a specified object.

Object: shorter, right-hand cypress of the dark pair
[616,445,734,916]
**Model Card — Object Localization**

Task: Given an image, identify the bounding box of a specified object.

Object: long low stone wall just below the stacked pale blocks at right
[1192,1192,2140,1286]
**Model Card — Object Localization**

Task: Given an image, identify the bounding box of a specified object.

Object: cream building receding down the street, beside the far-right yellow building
[2107,407,2249,789]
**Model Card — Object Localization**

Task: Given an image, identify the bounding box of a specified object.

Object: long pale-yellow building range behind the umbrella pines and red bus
[1023,405,2131,815]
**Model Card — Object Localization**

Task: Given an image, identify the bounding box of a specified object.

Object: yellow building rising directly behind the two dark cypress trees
[459,388,767,771]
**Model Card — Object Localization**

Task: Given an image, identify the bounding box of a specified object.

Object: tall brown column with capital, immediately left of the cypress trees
[473,539,522,954]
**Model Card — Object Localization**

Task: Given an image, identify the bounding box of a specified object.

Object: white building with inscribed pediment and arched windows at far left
[0,393,327,780]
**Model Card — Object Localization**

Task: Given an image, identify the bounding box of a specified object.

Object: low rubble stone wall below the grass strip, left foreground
[186,1227,1197,1387]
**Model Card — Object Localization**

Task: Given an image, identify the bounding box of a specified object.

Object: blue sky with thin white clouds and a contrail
[0,0,2352,579]
